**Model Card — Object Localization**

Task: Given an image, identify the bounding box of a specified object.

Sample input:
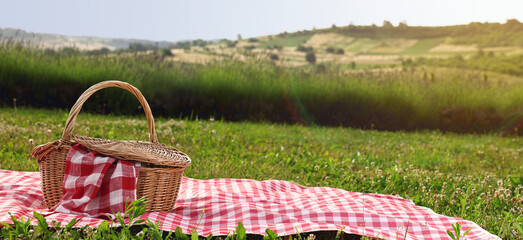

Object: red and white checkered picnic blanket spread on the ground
[0,170,500,239]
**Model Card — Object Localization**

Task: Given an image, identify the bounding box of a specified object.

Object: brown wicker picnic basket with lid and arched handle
[31,81,191,212]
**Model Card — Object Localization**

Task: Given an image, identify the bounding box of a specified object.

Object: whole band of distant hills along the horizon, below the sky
[0,19,523,66]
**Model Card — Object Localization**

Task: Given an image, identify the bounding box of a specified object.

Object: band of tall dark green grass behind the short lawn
[0,42,523,133]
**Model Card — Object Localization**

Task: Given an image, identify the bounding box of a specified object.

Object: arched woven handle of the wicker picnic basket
[61,80,158,143]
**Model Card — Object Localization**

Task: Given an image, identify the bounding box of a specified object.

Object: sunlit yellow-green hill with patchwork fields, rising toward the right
[163,20,523,68]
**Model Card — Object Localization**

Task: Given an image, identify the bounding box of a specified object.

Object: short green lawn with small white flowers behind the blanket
[0,108,523,239]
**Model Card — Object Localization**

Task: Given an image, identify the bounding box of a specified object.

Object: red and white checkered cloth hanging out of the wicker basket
[53,144,140,219]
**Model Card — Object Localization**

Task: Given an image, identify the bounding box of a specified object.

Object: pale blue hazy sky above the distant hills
[0,0,523,41]
